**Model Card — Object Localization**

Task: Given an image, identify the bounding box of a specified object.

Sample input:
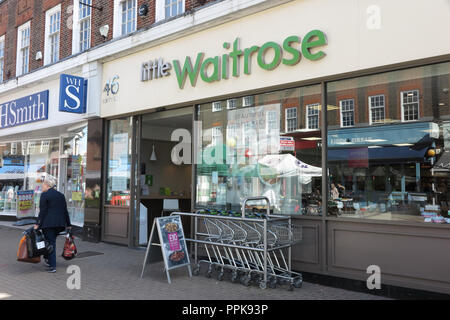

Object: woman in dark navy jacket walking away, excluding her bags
[34,179,72,273]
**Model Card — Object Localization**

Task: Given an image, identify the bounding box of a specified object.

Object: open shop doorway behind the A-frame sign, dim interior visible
[134,107,193,246]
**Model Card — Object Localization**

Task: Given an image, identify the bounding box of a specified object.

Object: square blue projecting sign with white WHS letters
[59,74,87,113]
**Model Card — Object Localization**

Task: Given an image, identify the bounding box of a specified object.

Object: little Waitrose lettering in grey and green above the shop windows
[140,30,327,89]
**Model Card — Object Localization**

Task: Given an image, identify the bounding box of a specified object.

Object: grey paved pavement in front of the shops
[0,222,385,301]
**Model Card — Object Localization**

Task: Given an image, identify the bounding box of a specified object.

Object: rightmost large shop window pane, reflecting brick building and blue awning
[327,63,450,222]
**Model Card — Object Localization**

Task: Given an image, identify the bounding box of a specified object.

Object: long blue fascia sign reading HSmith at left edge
[0,90,48,129]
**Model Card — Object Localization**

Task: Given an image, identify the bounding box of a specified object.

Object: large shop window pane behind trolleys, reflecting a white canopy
[196,86,322,215]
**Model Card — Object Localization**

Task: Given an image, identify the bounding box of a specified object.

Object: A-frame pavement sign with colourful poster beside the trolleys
[141,216,192,284]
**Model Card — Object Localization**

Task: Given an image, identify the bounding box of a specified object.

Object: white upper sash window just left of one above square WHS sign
[44,5,61,64]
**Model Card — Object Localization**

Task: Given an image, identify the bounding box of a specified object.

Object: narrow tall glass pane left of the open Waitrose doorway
[106,117,132,206]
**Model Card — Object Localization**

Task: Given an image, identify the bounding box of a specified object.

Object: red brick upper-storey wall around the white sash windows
[0,0,216,81]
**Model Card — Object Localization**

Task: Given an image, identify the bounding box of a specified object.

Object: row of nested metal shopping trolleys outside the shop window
[173,210,303,290]
